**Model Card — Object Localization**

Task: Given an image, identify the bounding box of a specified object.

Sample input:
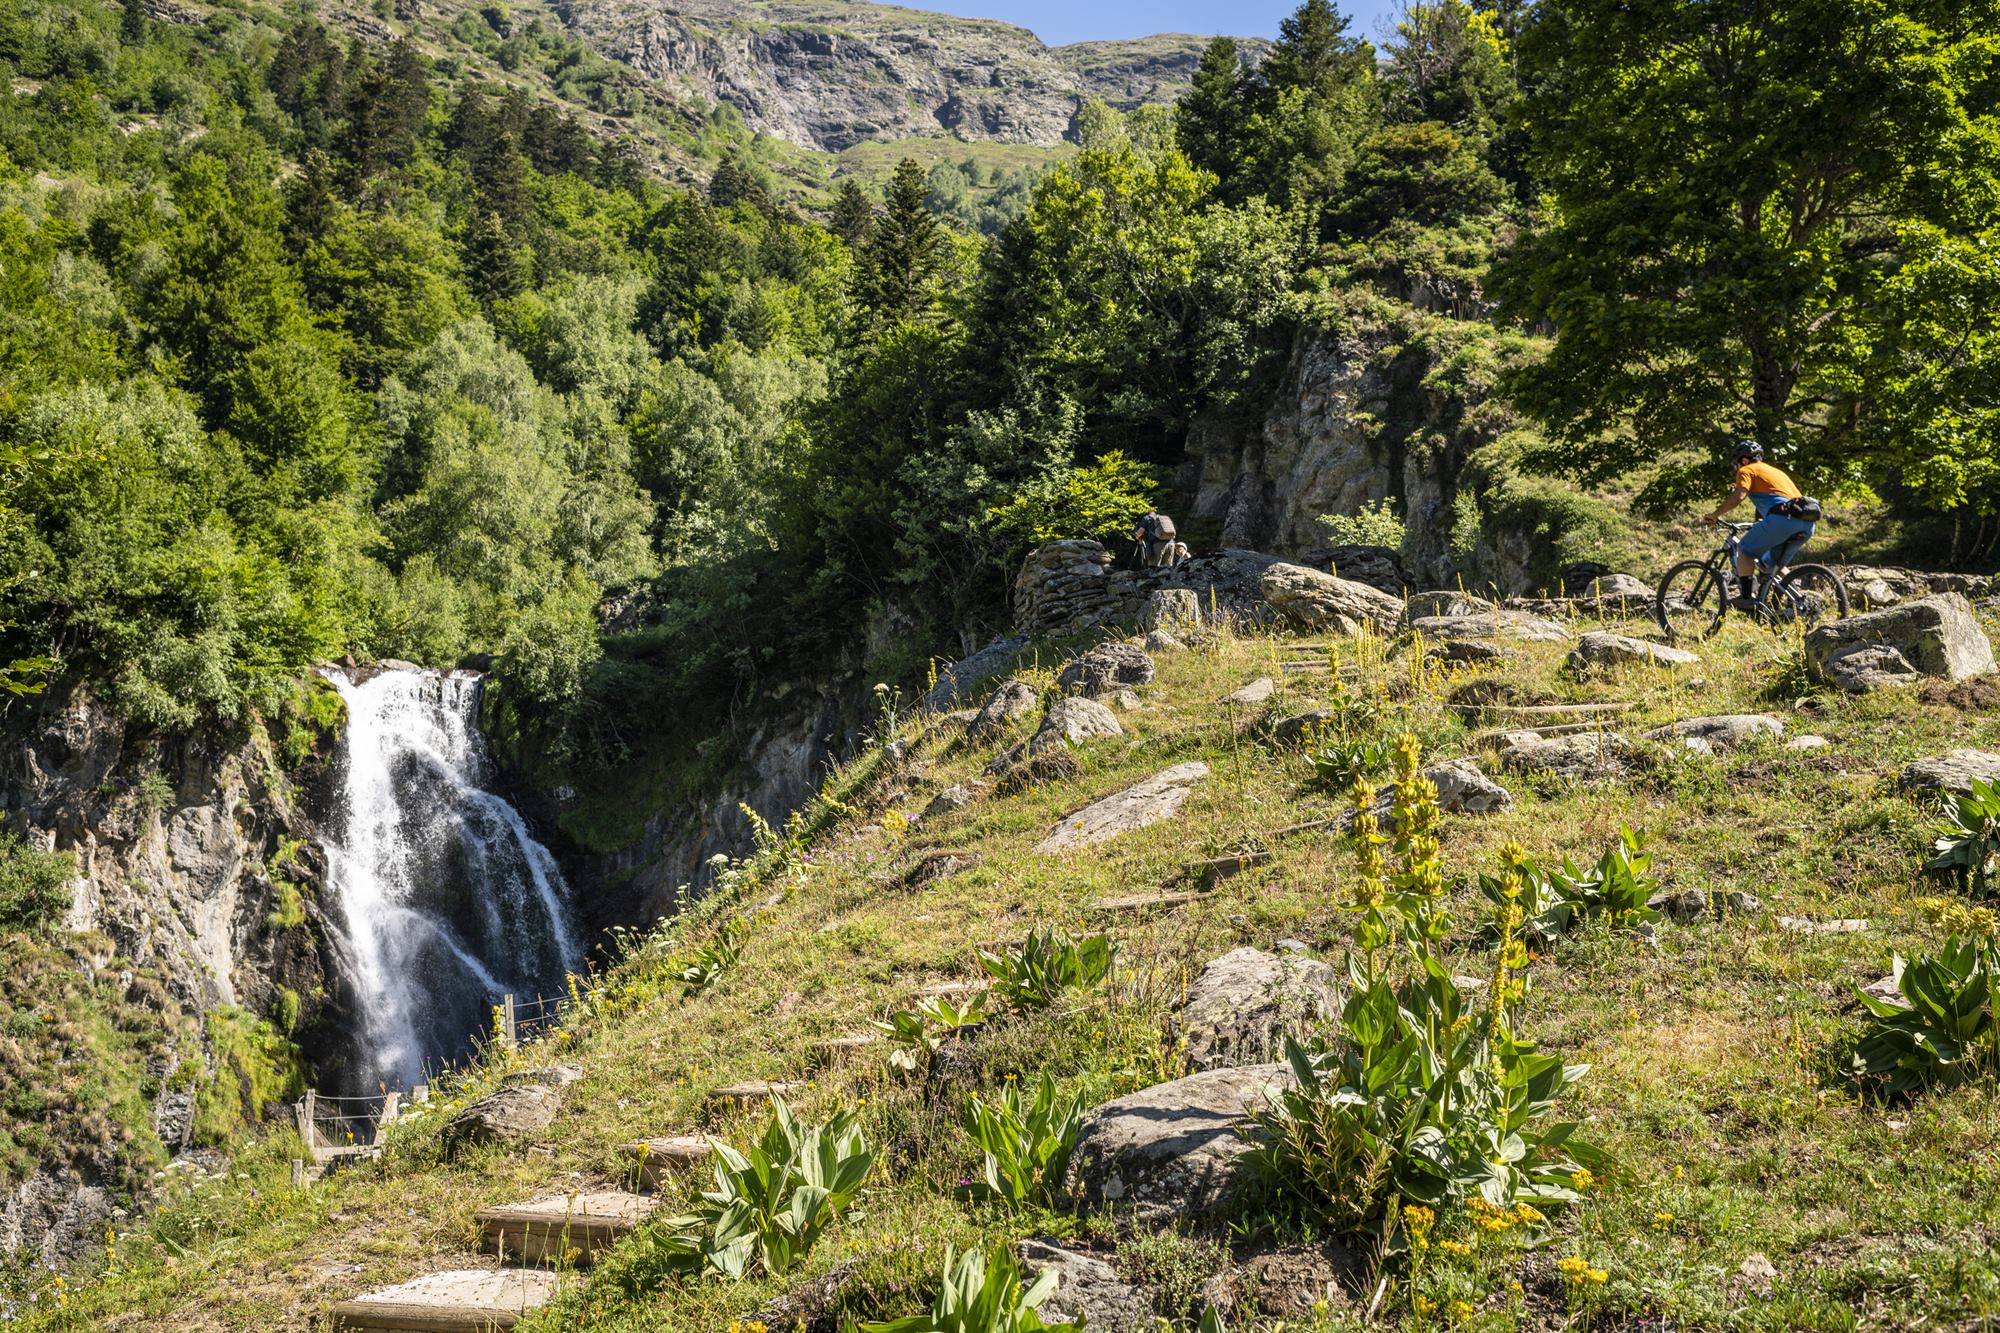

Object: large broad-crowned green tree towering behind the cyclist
[1508,0,2000,508]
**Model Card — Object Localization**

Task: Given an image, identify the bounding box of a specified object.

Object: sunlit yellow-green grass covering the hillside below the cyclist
[15,596,2000,1331]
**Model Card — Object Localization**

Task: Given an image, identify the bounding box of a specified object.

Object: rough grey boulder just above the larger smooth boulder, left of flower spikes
[1172,947,1340,1069]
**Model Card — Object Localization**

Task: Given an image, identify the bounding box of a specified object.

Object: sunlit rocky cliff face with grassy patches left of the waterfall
[0,689,334,1259]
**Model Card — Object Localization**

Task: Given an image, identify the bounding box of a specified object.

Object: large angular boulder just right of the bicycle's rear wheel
[1806,592,1996,695]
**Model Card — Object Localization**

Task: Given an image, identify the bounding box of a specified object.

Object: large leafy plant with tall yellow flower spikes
[1250,735,1588,1237]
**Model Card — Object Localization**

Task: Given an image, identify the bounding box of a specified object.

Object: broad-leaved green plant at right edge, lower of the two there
[1852,935,2000,1099]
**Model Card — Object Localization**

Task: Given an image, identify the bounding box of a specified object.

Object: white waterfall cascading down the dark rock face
[326,671,582,1091]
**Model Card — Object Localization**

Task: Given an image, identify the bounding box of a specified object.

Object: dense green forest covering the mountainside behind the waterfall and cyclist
[0,0,2000,800]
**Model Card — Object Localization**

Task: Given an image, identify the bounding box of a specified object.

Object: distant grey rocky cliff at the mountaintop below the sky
[556,0,1248,152]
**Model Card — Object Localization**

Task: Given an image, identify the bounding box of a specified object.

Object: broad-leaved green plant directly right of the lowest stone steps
[652,1099,874,1281]
